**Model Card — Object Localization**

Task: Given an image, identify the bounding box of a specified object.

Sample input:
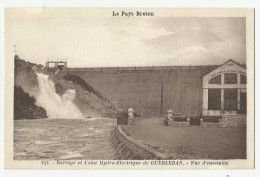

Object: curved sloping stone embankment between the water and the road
[111,125,171,160]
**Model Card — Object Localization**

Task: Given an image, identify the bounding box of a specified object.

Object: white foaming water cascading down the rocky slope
[35,72,83,119]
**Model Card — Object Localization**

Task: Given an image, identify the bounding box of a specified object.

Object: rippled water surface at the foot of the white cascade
[14,118,116,160]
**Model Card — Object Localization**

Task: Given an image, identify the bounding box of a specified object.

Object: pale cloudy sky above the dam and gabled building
[5,10,246,67]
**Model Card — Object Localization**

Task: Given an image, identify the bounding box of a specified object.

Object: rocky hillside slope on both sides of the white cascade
[15,57,118,117]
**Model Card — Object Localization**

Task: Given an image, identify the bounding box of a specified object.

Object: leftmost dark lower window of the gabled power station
[208,89,221,110]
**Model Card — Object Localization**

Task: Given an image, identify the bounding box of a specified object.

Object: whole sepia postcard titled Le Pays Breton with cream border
[4,8,254,169]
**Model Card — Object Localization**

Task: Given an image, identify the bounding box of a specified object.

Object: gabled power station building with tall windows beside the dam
[202,59,247,116]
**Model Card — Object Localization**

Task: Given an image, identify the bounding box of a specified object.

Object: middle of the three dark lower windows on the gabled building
[224,89,237,111]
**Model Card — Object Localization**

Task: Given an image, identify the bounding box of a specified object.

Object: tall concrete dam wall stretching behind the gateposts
[68,65,217,115]
